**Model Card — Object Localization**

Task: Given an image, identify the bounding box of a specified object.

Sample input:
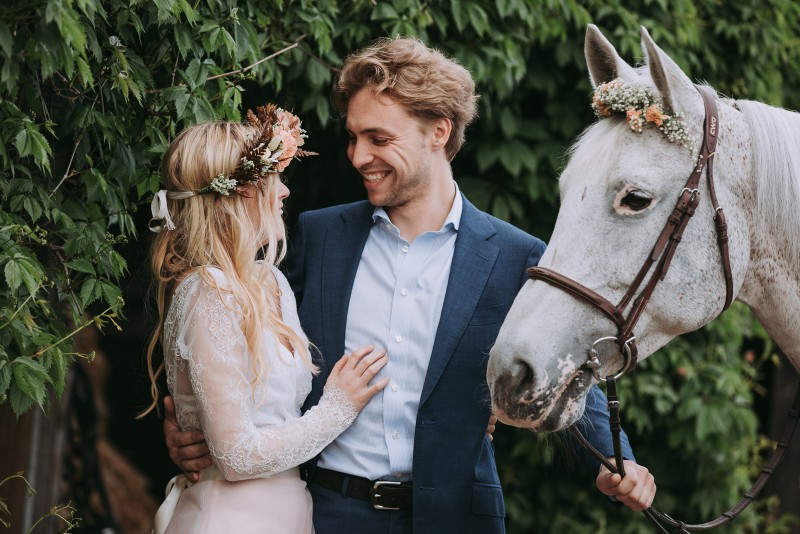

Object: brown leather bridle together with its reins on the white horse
[527,86,800,533]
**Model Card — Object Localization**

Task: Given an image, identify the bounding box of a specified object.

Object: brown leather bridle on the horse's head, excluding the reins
[528,86,733,381]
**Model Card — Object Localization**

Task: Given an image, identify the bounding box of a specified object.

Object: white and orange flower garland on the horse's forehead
[592,78,694,155]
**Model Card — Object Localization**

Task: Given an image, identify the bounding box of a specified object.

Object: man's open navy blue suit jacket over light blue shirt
[286,198,632,534]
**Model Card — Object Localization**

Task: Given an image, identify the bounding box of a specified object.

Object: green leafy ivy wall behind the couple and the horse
[0,0,800,533]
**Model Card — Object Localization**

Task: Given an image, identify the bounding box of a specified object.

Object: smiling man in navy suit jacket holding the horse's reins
[165,38,655,534]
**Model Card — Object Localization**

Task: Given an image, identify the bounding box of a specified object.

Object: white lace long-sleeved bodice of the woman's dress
[163,269,358,480]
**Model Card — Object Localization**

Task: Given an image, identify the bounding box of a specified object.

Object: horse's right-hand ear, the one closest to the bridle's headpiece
[641,26,703,118]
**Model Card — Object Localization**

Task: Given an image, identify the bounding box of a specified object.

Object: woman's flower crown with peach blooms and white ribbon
[148,104,317,232]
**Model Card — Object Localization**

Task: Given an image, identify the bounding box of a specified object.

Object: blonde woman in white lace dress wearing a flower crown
[142,105,389,533]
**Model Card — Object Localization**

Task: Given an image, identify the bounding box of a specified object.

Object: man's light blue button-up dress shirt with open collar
[319,186,462,481]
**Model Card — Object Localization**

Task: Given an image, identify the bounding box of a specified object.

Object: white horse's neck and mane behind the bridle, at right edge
[720,101,800,370]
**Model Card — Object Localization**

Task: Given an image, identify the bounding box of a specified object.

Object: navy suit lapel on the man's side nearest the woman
[320,202,374,366]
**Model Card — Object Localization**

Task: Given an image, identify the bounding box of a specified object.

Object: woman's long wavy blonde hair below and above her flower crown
[139,121,316,417]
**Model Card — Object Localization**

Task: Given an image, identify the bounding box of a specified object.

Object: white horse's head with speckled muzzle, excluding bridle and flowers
[488,26,750,431]
